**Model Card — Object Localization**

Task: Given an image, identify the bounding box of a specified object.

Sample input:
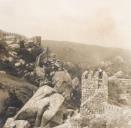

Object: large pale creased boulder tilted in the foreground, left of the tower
[15,85,64,127]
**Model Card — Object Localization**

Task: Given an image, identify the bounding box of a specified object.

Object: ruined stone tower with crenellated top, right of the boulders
[80,70,108,117]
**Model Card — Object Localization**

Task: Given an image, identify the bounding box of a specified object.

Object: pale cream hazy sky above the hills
[0,0,131,48]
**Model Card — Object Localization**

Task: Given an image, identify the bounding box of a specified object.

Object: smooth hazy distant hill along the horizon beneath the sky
[42,40,131,66]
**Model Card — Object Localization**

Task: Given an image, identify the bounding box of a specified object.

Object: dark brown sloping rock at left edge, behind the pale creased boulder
[0,74,37,104]
